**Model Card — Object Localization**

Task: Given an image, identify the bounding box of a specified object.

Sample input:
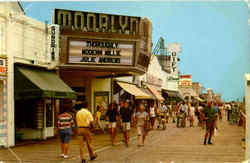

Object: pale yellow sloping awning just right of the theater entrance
[117,82,152,99]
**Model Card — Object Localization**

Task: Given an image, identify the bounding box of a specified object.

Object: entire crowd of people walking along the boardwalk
[58,100,242,163]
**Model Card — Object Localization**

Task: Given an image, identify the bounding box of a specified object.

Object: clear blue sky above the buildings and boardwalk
[21,1,250,101]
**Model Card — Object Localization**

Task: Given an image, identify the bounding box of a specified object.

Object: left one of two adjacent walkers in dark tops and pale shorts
[106,102,119,145]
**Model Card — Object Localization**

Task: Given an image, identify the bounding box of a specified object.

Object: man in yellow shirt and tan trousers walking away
[76,102,97,163]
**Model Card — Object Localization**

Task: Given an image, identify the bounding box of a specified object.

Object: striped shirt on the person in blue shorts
[57,113,74,130]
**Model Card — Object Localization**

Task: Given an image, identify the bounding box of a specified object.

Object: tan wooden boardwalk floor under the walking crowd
[0,118,244,163]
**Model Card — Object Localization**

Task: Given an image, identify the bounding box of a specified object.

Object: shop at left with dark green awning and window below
[14,64,76,142]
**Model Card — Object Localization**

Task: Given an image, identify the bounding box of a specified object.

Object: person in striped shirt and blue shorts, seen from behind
[57,108,75,158]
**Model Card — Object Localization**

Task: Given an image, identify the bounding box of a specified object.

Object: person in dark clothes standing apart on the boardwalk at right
[203,102,217,145]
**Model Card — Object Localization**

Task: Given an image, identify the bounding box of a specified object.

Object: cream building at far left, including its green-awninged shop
[0,2,73,147]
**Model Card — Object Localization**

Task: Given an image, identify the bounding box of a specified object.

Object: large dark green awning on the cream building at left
[14,66,76,99]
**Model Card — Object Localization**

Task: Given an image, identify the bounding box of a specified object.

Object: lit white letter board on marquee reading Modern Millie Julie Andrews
[68,40,134,65]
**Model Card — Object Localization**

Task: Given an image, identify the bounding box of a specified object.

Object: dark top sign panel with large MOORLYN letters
[53,9,141,35]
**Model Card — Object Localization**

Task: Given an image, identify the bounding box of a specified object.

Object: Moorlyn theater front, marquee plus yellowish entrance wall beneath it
[53,9,152,112]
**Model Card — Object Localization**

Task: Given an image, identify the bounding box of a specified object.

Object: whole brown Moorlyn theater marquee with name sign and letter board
[52,9,152,76]
